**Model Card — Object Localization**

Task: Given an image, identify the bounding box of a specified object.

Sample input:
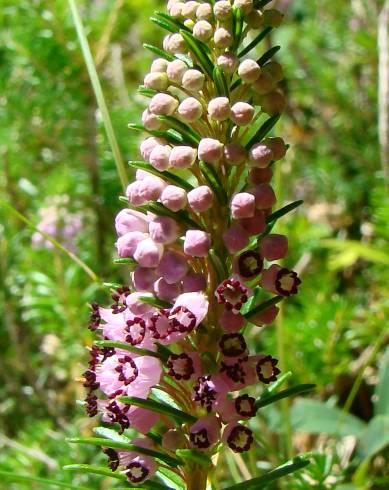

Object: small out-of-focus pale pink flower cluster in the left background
[31,195,83,252]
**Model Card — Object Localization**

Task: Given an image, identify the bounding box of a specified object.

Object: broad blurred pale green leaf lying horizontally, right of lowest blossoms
[291,399,366,438]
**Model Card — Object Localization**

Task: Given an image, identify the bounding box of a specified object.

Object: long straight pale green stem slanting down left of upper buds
[68,0,128,189]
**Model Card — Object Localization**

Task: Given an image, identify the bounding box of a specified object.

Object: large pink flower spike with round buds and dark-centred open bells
[80,0,300,490]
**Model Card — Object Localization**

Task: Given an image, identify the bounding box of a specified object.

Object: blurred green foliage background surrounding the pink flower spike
[0,0,389,490]
